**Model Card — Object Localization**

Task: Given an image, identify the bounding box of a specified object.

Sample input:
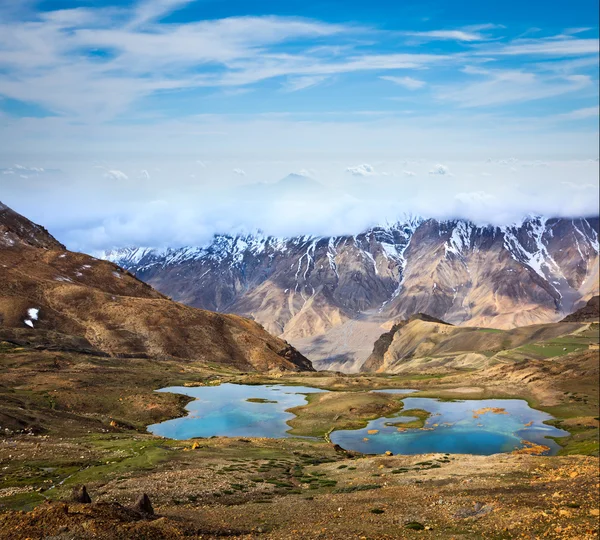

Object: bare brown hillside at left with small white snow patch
[0,200,312,370]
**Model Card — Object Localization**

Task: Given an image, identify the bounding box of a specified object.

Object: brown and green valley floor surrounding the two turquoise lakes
[0,344,600,540]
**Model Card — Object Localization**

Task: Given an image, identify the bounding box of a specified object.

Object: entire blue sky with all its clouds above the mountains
[0,0,599,252]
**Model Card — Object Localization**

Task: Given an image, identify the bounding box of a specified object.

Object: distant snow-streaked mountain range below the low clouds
[104,217,599,369]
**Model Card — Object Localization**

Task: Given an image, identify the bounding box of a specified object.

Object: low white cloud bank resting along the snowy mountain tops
[0,158,599,253]
